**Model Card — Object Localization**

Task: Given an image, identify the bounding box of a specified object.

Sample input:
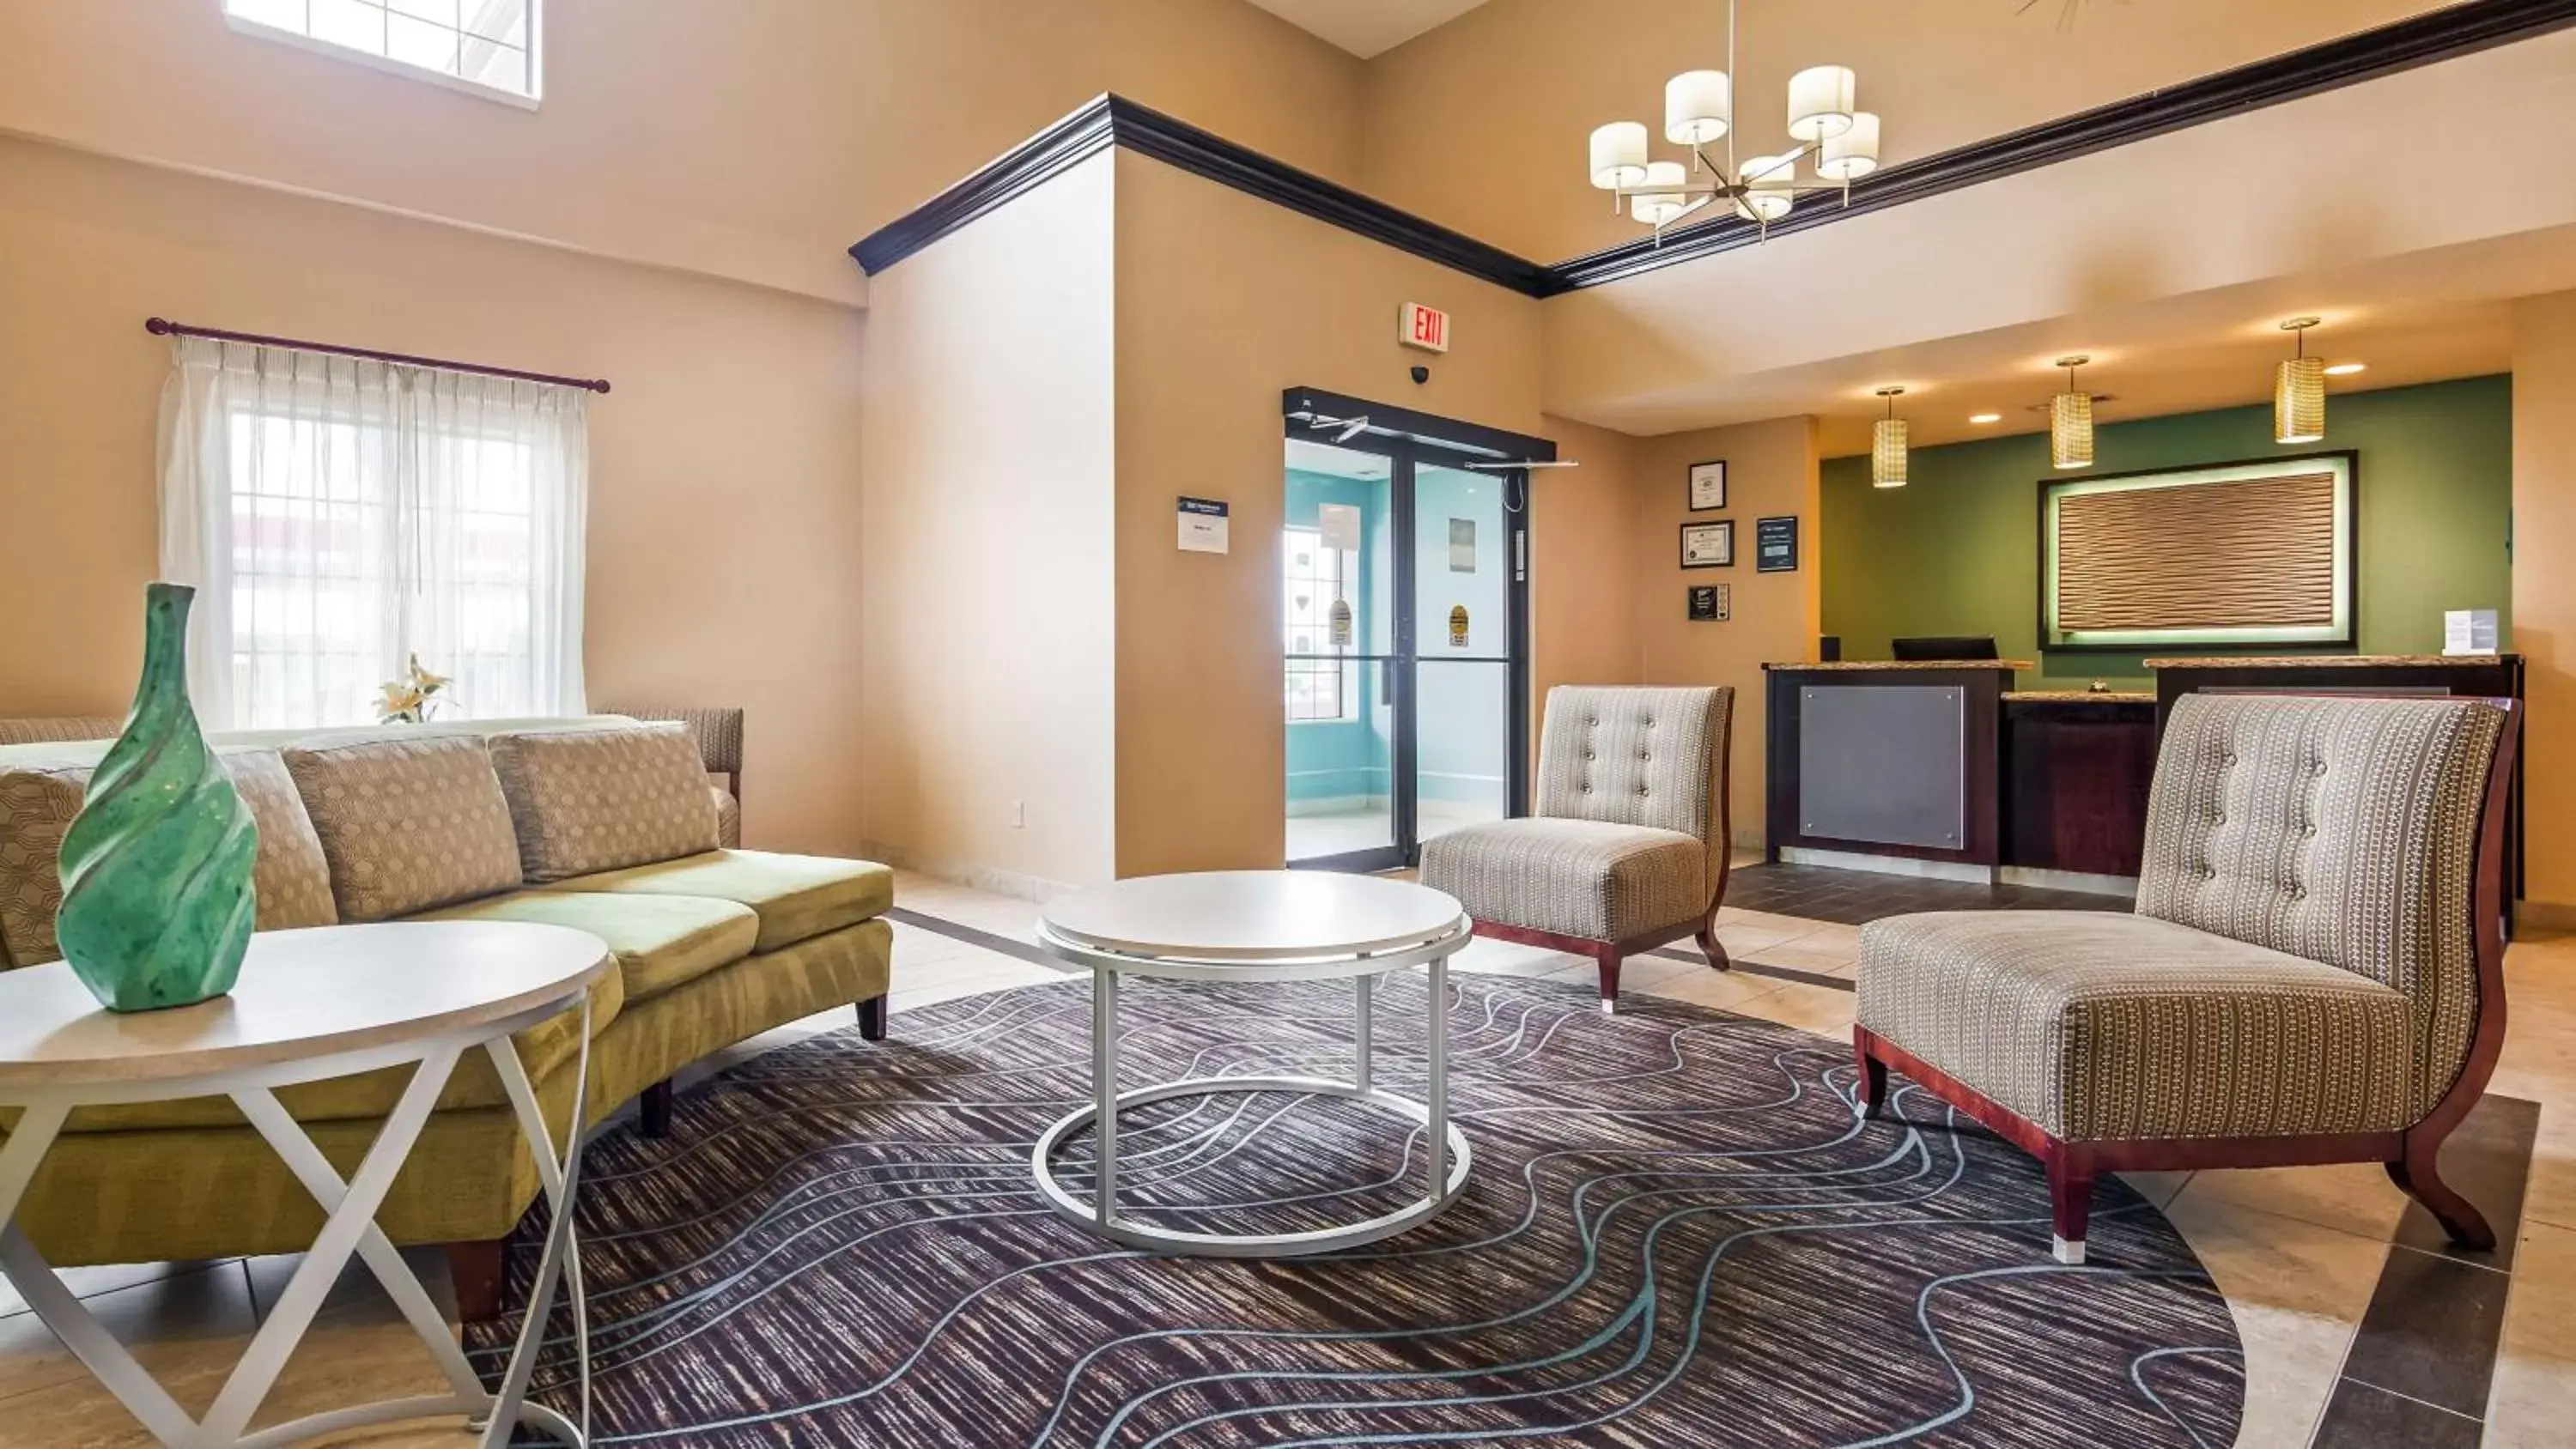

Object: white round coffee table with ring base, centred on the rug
[1030,870,1473,1258]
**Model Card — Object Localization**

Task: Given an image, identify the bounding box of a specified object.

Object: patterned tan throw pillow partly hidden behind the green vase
[0,749,340,965]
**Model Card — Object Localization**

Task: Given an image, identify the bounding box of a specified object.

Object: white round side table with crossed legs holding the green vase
[0,921,616,1449]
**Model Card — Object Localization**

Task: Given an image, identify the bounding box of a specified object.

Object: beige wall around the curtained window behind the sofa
[0,139,860,849]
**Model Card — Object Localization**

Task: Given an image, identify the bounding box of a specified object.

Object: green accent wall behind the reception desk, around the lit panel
[1819,376,2514,690]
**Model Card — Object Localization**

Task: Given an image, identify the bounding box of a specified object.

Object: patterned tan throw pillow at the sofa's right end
[492,724,716,882]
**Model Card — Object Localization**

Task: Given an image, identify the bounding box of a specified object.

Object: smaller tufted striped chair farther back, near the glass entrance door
[1422,685,1736,1011]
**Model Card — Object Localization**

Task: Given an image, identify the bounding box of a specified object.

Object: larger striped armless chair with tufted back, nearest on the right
[1852,695,2519,1264]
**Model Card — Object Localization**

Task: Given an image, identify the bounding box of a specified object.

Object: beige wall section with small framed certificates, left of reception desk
[1631,417,1826,844]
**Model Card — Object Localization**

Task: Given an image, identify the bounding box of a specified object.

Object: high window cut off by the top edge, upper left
[224,0,541,106]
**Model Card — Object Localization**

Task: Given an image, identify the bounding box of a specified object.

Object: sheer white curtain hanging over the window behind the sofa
[160,337,590,728]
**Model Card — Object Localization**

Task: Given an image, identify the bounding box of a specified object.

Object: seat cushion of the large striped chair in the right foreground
[1857,911,2416,1143]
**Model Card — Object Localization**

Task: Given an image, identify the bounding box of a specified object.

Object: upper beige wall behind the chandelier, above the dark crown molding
[1363,0,2434,263]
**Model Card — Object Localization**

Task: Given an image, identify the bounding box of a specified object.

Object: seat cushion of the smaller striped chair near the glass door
[1422,818,1708,942]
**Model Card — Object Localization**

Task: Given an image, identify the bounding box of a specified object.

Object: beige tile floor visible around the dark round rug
[0,875,2576,1449]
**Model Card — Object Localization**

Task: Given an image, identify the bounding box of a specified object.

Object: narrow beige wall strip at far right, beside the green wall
[2514,291,2576,926]
